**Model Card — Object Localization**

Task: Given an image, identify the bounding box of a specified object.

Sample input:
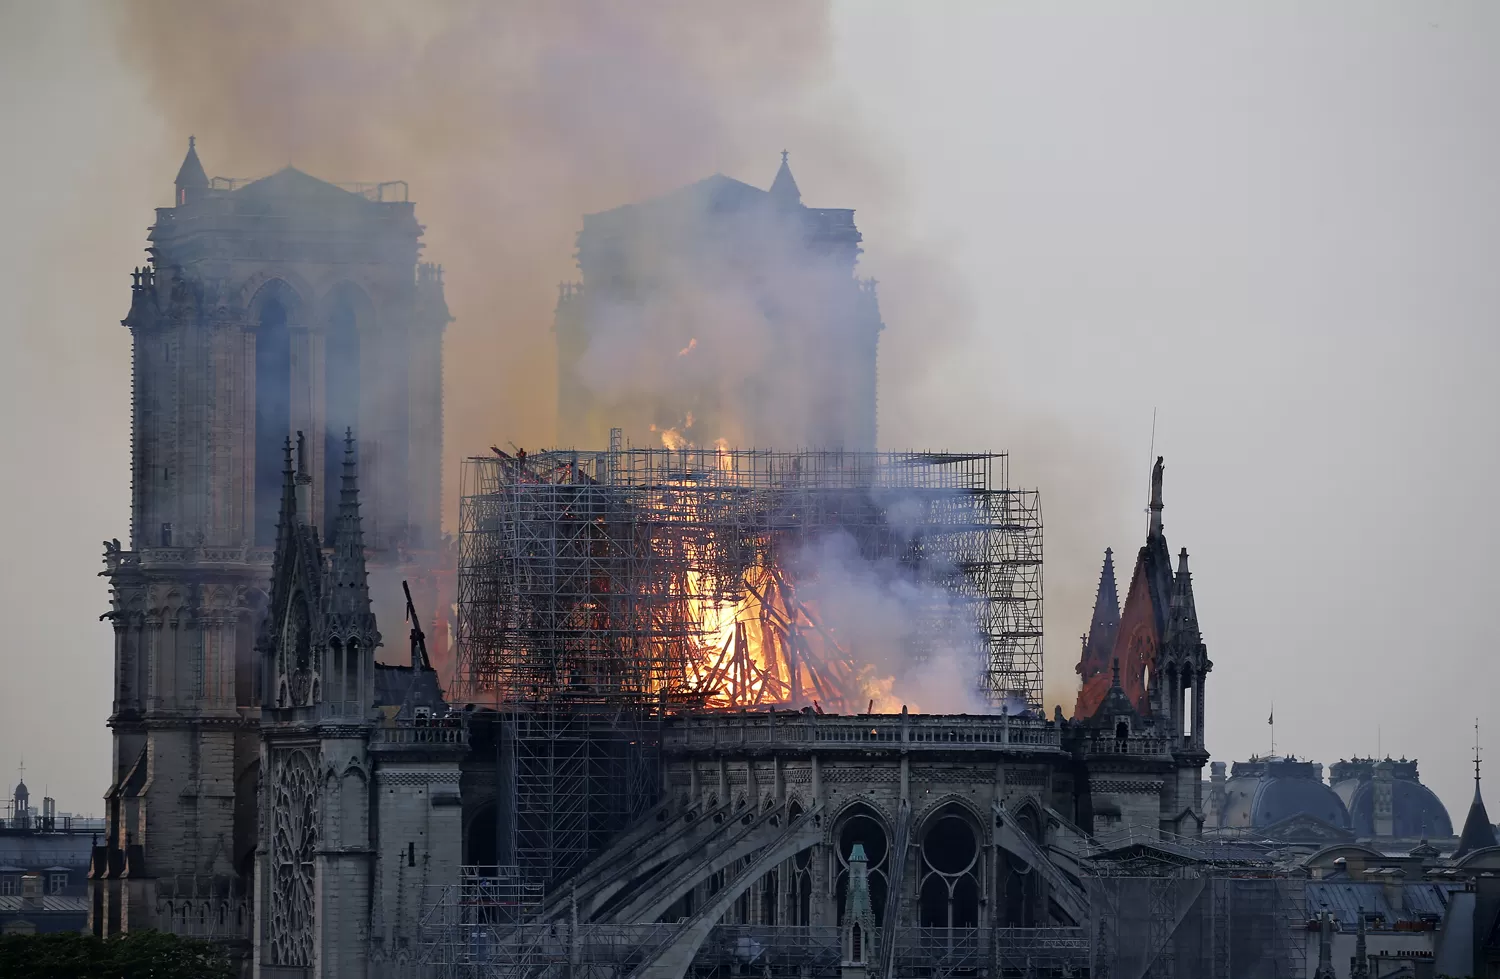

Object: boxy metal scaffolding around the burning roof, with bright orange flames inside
[458,447,1043,714]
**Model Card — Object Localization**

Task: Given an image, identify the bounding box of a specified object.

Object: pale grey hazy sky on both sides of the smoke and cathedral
[0,0,1500,823]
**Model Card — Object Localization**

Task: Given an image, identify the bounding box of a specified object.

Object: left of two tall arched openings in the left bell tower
[255,282,293,547]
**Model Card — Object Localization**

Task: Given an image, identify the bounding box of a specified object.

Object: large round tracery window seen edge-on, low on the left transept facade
[267,748,320,966]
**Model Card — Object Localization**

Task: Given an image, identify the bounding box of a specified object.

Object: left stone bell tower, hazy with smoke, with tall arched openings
[90,139,450,937]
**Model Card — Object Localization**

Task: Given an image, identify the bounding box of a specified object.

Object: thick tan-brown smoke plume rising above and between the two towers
[120,0,872,485]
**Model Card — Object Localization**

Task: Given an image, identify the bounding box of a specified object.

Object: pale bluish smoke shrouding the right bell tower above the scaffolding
[558,188,879,450]
